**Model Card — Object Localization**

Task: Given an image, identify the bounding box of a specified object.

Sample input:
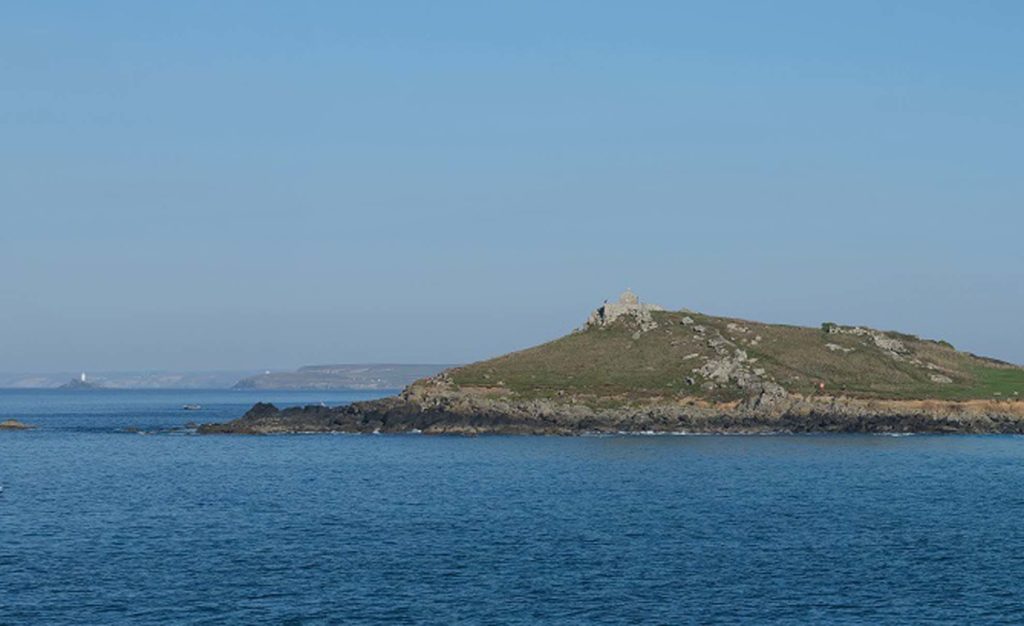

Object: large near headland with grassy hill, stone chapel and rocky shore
[200,291,1024,434]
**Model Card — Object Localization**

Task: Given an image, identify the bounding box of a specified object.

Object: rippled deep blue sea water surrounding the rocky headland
[0,391,1024,624]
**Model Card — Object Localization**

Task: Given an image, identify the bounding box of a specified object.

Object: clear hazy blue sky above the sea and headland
[0,0,1024,372]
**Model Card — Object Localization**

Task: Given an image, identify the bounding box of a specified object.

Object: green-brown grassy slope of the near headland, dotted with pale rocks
[449,310,1024,403]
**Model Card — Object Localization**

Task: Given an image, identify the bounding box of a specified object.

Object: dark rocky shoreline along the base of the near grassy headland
[198,385,1024,435]
